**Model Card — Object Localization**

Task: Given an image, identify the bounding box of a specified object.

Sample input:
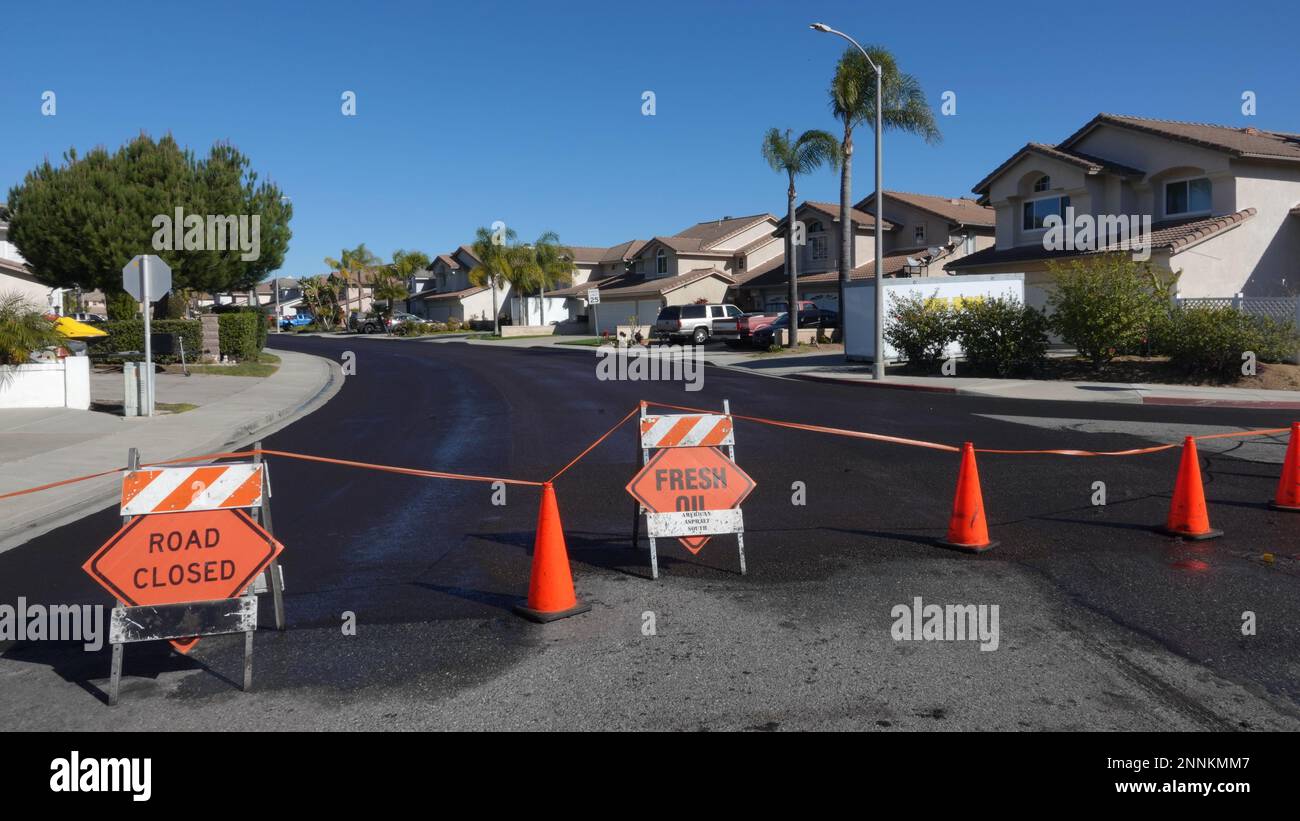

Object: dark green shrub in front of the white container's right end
[953,296,1048,377]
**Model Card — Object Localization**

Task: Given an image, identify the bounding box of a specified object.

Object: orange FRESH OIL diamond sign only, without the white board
[627,447,755,553]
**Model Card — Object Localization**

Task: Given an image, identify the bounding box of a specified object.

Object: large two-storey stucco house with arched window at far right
[945,114,1300,307]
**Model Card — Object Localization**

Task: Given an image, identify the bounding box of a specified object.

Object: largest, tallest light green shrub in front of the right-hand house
[1048,253,1178,366]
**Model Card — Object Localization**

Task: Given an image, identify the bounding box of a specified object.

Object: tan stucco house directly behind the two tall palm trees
[736,191,995,310]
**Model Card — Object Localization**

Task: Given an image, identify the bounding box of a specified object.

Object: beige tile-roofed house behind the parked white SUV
[553,214,781,331]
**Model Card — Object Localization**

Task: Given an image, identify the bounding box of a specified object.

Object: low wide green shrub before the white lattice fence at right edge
[1156,307,1300,379]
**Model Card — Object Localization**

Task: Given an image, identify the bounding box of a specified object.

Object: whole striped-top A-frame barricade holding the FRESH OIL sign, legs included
[627,400,754,578]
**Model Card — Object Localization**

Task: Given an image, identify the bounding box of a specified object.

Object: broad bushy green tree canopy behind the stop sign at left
[8,134,293,294]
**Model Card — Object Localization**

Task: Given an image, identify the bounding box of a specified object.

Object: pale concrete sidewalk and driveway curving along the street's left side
[0,349,343,552]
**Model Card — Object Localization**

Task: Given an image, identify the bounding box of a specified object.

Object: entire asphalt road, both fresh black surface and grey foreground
[0,338,1300,730]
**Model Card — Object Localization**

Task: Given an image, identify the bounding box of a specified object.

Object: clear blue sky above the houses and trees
[0,0,1300,275]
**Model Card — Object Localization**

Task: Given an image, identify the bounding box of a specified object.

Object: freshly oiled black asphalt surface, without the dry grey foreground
[0,336,1300,729]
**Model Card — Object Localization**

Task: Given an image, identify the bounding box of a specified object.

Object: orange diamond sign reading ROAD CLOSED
[82,509,285,652]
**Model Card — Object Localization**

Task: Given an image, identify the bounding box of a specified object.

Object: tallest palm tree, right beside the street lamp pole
[829,45,943,336]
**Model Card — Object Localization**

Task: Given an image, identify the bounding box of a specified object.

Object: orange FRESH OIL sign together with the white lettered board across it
[627,447,755,553]
